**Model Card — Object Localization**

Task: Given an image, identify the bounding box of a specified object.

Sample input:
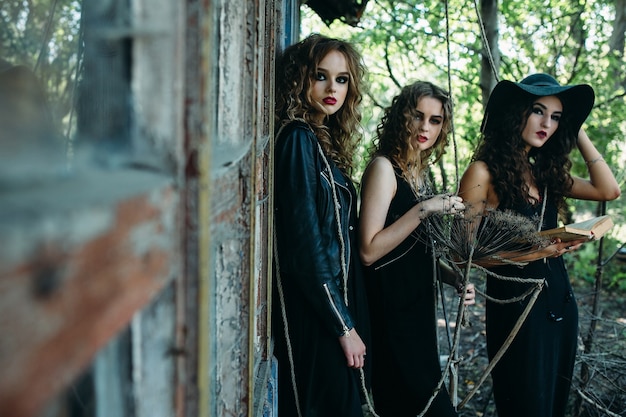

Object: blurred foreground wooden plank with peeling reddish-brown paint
[0,187,178,417]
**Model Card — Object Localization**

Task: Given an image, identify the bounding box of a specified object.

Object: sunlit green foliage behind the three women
[302,0,626,286]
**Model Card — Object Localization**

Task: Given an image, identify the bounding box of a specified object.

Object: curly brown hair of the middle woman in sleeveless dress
[369,81,452,176]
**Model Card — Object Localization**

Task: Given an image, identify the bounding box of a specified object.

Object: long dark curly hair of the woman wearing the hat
[472,94,576,209]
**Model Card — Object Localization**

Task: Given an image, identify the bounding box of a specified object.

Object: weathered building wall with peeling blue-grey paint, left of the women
[0,0,299,417]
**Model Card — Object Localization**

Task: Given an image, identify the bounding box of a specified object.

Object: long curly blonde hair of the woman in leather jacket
[275,34,365,175]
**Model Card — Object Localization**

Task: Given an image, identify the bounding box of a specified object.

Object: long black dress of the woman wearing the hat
[486,196,578,417]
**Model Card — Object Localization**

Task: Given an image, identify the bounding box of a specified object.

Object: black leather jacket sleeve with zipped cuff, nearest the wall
[274,126,354,336]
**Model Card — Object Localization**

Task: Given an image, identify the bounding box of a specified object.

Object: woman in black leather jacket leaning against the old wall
[273,35,369,417]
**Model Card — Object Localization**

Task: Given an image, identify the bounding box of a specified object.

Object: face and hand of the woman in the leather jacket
[309,51,366,369]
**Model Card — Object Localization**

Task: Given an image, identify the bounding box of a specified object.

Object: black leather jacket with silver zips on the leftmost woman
[274,121,356,336]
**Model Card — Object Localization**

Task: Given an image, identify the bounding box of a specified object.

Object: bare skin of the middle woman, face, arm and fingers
[359,97,475,305]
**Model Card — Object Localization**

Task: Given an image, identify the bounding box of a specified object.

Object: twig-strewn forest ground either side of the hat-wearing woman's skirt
[440,274,626,417]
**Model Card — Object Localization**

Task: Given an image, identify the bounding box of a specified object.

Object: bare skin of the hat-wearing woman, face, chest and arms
[459,96,620,262]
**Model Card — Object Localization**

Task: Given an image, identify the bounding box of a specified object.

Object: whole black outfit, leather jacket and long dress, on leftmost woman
[272,122,369,417]
